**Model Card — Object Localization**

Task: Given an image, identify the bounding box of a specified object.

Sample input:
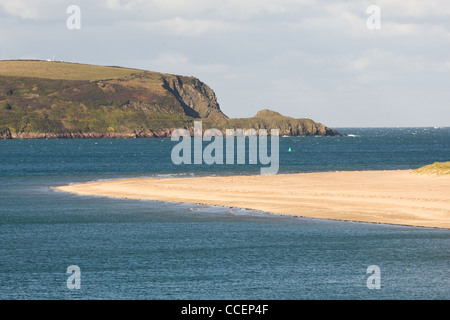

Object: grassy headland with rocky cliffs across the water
[0,60,338,138]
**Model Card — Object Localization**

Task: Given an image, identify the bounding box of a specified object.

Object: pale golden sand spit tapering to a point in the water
[56,170,450,229]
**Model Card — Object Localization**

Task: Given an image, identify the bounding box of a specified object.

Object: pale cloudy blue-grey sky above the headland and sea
[0,0,450,128]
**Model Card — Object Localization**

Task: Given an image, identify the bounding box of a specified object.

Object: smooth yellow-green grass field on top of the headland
[0,60,144,81]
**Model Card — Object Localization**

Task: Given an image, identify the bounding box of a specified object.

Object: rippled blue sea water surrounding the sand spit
[0,128,450,300]
